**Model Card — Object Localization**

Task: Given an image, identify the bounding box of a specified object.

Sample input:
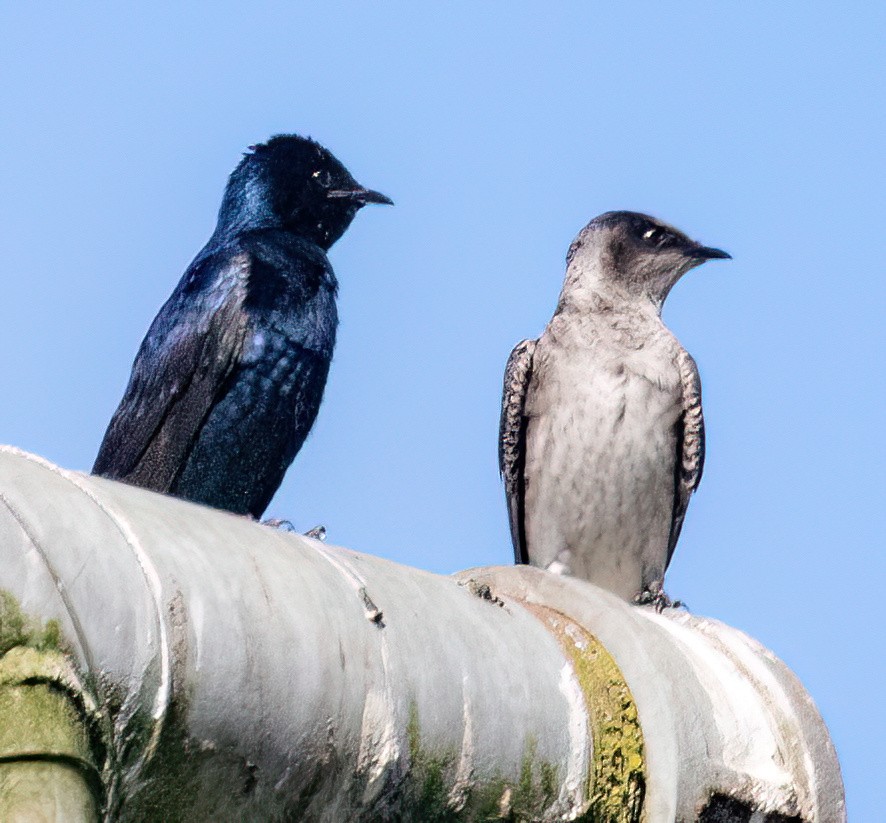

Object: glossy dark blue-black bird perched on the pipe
[93,135,391,518]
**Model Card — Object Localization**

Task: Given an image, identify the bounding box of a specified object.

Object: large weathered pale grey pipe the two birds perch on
[0,448,845,823]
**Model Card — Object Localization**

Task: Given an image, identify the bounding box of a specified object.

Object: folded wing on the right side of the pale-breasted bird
[667,350,704,563]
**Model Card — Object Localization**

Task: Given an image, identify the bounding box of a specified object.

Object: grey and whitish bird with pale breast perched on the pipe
[499,211,730,608]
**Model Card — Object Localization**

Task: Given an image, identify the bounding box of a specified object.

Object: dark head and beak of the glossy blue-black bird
[219,134,392,249]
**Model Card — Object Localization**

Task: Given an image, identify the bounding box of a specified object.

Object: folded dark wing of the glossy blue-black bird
[92,253,251,491]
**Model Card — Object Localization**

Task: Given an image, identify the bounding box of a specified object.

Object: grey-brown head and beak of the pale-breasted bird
[566,211,730,308]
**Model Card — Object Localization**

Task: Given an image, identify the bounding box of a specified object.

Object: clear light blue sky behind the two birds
[0,0,886,820]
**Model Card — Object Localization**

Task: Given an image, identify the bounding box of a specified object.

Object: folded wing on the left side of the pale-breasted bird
[498,340,538,563]
